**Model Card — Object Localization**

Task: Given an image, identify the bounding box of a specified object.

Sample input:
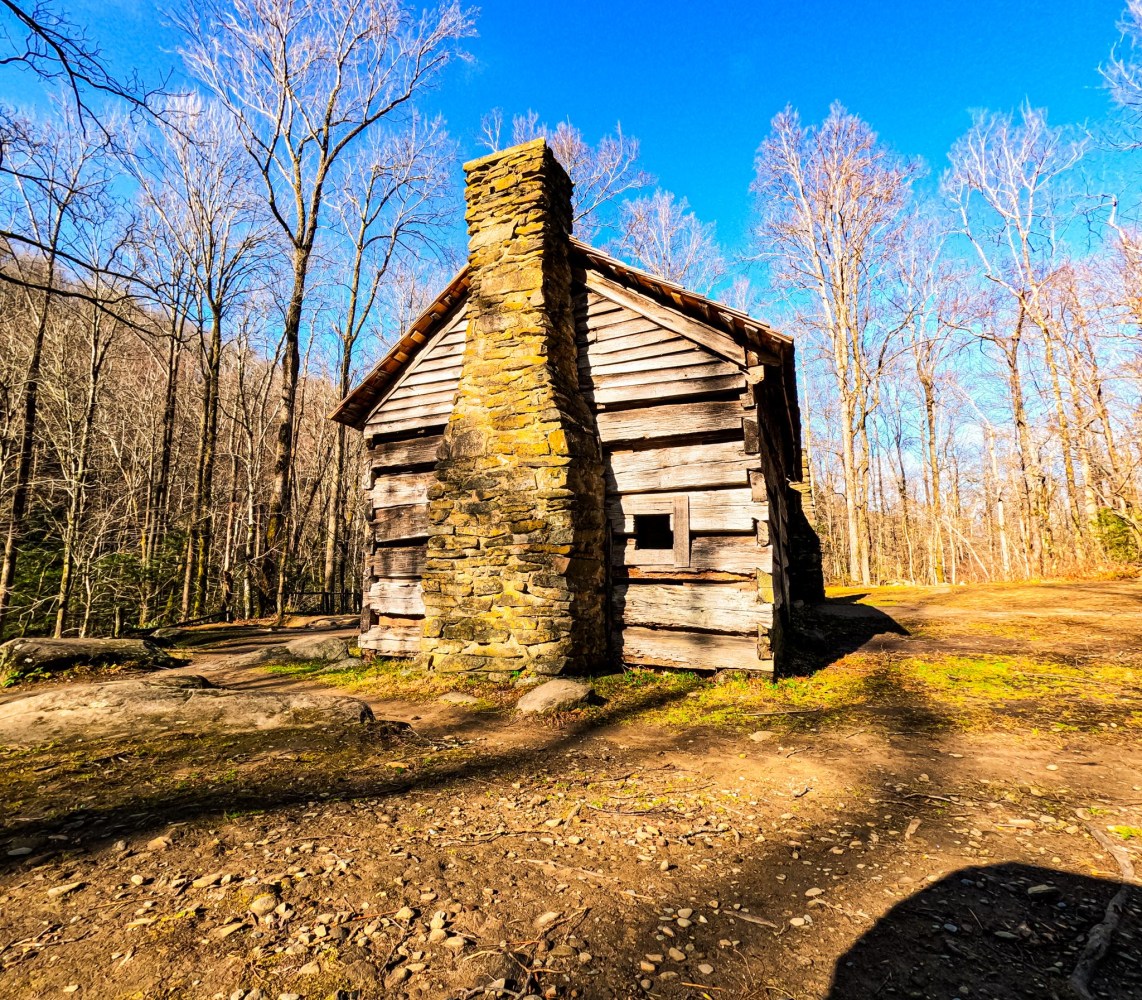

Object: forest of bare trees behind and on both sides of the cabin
[0,0,1142,637]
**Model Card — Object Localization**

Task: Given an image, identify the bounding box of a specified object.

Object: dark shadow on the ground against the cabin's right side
[785,594,909,677]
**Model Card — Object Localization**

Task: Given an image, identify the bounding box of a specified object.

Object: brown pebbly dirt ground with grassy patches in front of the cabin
[0,581,1142,1000]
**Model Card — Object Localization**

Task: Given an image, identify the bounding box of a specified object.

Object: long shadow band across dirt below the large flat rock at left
[0,688,685,872]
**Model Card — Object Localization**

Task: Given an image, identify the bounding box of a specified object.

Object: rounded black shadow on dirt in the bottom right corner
[826,863,1142,1000]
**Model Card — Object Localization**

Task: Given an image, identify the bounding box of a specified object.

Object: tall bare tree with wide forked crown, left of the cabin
[176,0,472,614]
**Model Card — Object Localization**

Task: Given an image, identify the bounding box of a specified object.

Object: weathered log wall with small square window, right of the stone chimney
[579,275,773,670]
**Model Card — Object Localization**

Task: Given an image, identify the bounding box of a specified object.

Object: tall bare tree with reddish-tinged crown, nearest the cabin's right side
[753,104,917,583]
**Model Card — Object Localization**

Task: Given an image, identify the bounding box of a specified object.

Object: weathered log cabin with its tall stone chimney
[331,139,822,676]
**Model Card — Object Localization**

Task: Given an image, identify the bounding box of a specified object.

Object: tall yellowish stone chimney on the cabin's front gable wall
[421,139,606,675]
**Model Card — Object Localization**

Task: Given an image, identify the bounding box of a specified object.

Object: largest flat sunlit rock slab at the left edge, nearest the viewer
[0,676,375,743]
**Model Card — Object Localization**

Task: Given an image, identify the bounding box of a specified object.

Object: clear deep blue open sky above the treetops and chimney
[28,0,1124,248]
